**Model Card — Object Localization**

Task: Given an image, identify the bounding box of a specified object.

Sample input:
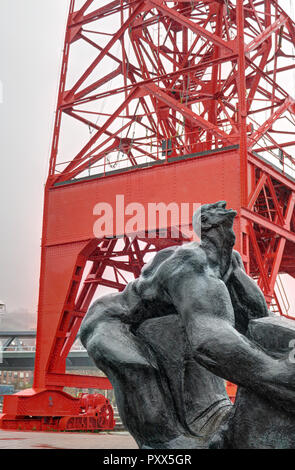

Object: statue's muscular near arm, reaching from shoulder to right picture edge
[168,270,295,411]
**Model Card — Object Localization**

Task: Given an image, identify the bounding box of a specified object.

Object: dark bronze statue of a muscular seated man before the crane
[81,201,295,449]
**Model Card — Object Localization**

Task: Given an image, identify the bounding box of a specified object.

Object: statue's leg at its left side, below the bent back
[84,318,190,447]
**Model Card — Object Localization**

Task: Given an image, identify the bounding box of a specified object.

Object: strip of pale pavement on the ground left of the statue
[0,429,138,449]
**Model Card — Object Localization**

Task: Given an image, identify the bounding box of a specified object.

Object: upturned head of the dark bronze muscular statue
[193,201,237,238]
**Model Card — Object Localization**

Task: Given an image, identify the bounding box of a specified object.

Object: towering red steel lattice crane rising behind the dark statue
[2,0,295,429]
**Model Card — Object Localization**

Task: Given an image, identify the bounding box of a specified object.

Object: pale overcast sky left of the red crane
[0,0,295,326]
